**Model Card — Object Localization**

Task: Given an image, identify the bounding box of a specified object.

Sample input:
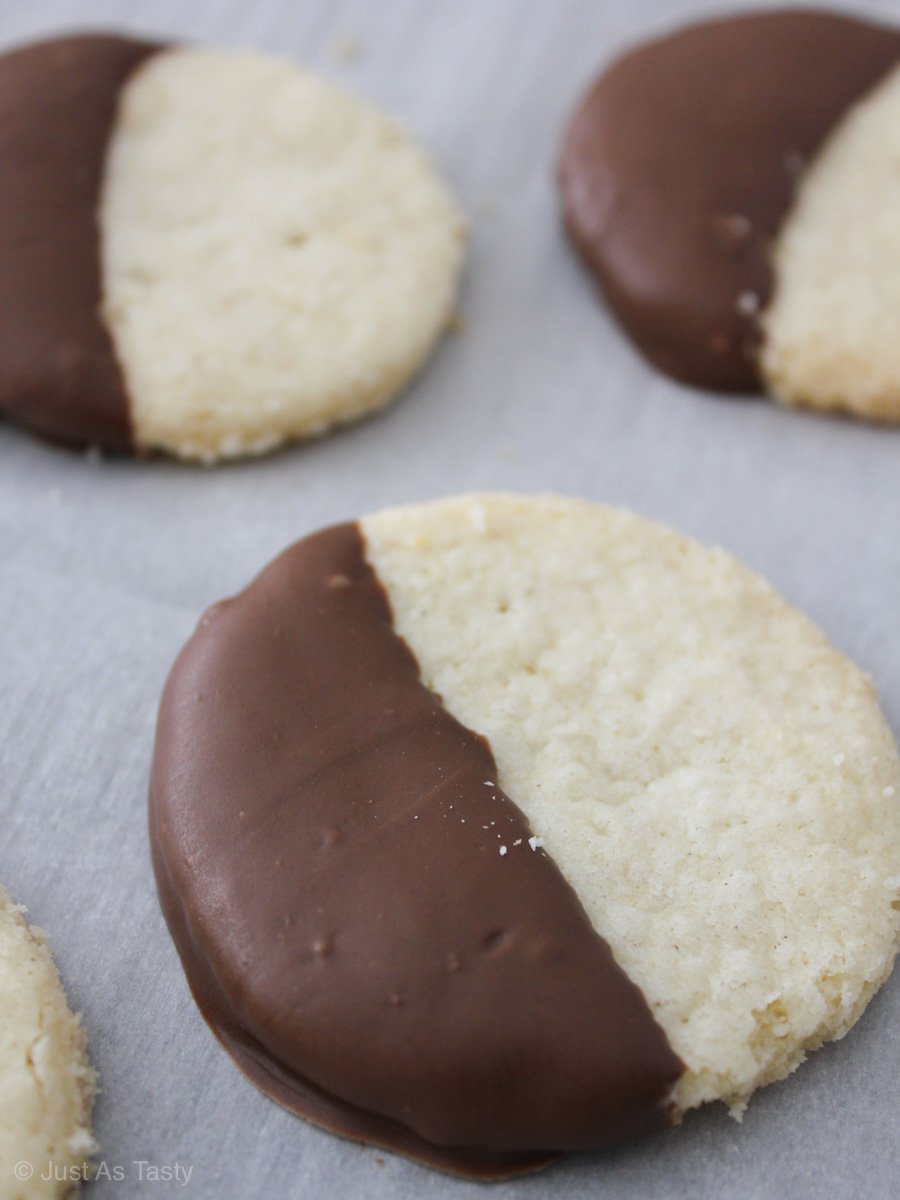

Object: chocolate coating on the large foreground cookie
[150,524,684,1178]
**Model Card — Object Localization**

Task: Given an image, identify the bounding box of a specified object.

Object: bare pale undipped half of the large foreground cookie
[362,494,900,1116]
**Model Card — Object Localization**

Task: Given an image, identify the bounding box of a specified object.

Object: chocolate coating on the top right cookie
[560,11,900,391]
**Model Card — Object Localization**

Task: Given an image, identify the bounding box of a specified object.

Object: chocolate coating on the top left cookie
[0,36,160,451]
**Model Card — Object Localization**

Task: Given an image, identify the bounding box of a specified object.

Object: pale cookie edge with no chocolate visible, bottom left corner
[0,888,96,1200]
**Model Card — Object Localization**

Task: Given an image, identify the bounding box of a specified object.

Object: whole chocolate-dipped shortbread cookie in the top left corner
[0,36,463,462]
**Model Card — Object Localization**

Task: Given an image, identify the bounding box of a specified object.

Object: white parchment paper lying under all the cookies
[0,0,900,1200]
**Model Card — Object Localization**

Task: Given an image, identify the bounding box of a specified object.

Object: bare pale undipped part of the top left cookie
[101,47,464,461]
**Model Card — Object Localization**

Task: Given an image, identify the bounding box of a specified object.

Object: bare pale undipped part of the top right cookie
[761,68,900,421]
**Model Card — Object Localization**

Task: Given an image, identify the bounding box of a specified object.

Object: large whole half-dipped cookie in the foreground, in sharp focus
[150,496,900,1177]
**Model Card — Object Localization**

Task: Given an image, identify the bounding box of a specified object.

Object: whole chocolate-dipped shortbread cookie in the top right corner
[560,10,900,419]
